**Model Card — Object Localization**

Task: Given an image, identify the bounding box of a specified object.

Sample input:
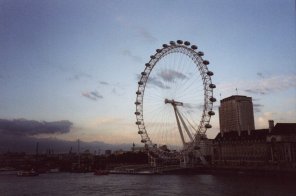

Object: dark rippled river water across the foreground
[0,173,296,196]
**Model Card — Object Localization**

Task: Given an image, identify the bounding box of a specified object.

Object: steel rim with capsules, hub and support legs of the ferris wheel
[135,40,216,162]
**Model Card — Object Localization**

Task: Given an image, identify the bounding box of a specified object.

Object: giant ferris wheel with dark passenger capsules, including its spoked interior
[135,40,216,161]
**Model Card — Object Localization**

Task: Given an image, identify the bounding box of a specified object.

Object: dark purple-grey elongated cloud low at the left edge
[0,119,73,136]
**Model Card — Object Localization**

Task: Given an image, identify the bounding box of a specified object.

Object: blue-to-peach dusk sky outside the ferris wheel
[0,0,296,151]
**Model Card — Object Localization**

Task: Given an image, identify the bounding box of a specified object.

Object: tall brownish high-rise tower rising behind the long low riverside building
[219,95,255,134]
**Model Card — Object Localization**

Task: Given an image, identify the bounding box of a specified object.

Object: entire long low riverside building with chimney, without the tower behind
[212,121,296,170]
